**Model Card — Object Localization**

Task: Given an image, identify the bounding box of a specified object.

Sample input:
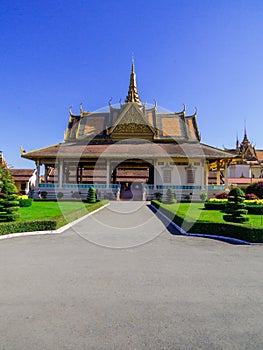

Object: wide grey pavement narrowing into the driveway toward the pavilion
[0,202,263,350]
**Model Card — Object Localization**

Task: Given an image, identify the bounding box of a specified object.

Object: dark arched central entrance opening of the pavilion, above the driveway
[111,159,154,201]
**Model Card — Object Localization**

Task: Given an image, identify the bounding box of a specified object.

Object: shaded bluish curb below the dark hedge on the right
[150,204,256,245]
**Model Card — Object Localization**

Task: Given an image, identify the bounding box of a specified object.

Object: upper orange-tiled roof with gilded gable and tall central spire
[61,59,200,143]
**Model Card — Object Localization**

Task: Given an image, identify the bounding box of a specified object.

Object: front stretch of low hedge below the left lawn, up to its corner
[0,220,57,235]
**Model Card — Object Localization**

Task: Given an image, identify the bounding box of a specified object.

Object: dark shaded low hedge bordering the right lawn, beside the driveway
[151,200,263,243]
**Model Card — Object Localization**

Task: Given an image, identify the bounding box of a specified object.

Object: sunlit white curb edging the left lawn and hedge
[0,203,110,240]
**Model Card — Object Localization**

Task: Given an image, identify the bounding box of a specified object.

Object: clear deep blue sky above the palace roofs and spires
[0,0,263,168]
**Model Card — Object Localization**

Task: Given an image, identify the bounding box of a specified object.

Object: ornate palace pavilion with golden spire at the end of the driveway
[22,62,234,200]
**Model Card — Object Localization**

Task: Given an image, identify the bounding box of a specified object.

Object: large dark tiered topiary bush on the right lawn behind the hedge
[223,187,249,223]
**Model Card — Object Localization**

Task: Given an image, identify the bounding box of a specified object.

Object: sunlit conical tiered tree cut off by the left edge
[0,167,19,221]
